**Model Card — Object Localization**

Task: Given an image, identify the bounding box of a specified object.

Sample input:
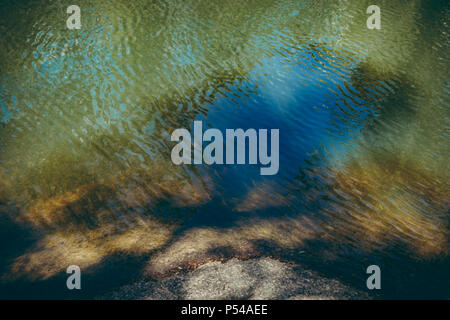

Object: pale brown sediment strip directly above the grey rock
[146,217,316,277]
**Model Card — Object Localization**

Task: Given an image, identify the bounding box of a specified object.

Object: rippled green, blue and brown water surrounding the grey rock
[0,1,450,298]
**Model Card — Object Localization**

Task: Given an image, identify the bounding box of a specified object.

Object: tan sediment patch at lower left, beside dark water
[8,221,172,281]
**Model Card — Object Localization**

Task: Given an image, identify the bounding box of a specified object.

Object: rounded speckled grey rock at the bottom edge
[99,257,370,300]
